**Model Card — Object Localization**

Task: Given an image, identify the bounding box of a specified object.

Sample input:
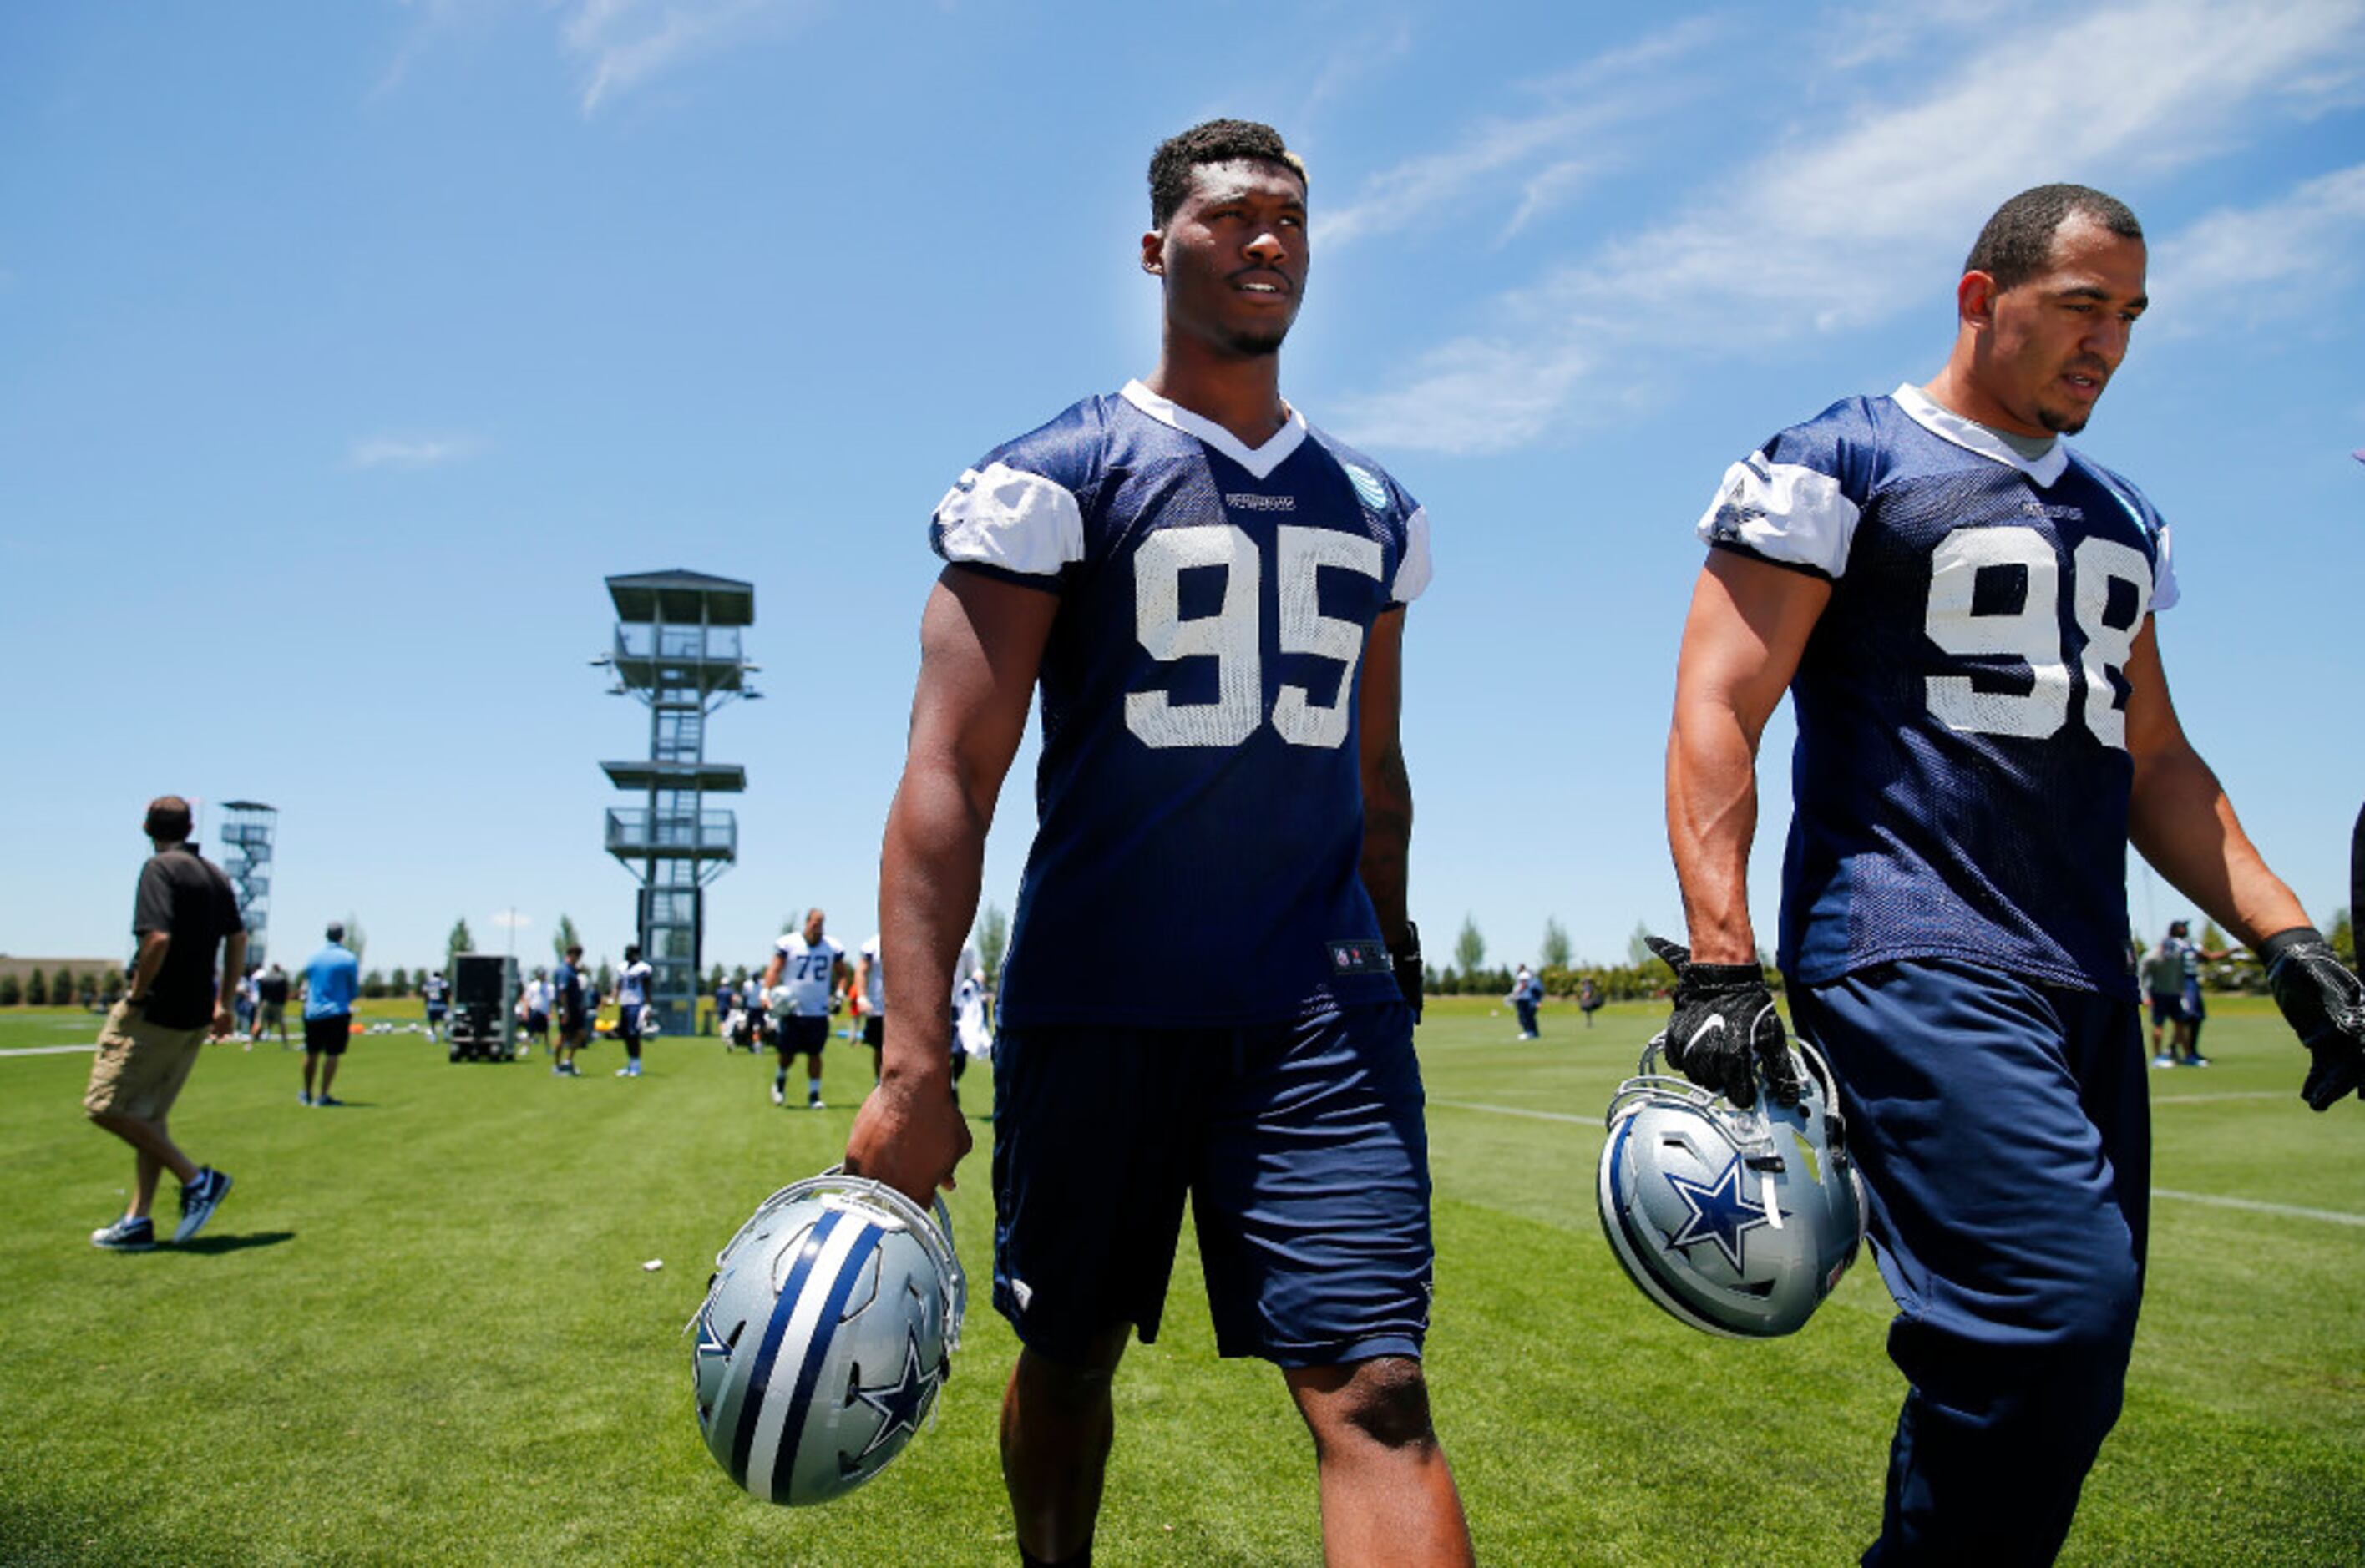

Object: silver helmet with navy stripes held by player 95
[691,1168,967,1505]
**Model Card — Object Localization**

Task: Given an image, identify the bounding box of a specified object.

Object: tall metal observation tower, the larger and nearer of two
[591,570,764,1034]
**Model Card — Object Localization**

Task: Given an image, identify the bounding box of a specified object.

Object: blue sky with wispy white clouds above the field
[0,0,2365,984]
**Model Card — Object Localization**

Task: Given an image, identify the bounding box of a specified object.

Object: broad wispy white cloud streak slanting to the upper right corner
[1341,0,2365,452]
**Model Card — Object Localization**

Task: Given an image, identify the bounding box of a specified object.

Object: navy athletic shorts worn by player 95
[993,1003,1436,1367]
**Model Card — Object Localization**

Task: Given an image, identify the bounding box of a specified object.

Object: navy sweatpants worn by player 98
[1790,958,2152,1565]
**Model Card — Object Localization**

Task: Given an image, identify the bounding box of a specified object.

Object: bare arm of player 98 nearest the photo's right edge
[2126,620,2308,948]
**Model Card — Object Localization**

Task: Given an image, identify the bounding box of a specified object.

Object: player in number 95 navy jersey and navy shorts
[847,120,1469,1563]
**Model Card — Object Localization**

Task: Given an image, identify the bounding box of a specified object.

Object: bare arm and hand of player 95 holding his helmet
[847,565,1060,1204]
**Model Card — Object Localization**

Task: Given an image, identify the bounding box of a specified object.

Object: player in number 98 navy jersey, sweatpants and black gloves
[1665,185,2365,1563]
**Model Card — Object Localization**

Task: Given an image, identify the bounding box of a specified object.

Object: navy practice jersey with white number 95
[932,381,1429,1026]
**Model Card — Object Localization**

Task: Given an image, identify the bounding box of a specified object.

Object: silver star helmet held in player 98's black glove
[1594,1040,1864,1338]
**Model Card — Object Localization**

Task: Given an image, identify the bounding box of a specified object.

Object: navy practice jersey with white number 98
[1700,386,2175,998]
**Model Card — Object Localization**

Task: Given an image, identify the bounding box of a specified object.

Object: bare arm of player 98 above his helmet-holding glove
[1668,551,1831,965]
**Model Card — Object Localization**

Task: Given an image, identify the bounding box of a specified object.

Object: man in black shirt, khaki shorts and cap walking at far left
[83,795,246,1251]
